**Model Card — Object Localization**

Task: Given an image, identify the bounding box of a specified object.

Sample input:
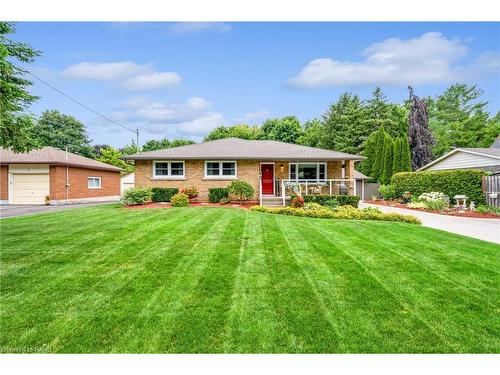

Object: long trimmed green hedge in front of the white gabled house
[391,169,485,205]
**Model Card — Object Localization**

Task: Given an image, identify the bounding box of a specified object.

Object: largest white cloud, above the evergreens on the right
[289,32,467,88]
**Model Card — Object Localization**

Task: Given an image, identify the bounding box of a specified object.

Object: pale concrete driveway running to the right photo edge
[359,202,500,244]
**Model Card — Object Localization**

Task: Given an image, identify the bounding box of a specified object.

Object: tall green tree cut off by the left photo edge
[0,22,40,152]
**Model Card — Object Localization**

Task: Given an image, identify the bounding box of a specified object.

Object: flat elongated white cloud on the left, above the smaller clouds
[62,61,182,91]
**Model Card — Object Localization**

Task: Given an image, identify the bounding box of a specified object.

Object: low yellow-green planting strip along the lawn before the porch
[251,206,421,224]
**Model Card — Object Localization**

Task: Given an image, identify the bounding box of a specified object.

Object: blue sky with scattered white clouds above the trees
[15,23,500,146]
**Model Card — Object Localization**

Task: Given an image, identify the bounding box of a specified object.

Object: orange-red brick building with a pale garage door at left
[0,147,121,205]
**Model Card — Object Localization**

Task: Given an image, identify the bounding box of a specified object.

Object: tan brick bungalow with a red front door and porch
[123,138,363,204]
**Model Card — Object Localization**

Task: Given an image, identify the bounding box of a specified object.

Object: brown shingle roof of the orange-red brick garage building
[0,147,121,172]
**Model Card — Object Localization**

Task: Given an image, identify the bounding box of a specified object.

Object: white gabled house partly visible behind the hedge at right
[419,137,500,174]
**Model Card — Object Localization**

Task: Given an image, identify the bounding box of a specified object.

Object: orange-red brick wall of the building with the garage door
[50,165,120,200]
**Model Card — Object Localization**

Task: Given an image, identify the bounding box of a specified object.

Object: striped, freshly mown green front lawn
[0,205,500,353]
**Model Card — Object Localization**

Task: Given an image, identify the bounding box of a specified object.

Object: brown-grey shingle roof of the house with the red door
[123,138,364,161]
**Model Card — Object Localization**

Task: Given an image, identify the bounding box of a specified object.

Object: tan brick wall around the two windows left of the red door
[135,160,260,201]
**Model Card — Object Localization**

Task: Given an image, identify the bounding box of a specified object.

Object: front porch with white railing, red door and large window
[259,160,356,206]
